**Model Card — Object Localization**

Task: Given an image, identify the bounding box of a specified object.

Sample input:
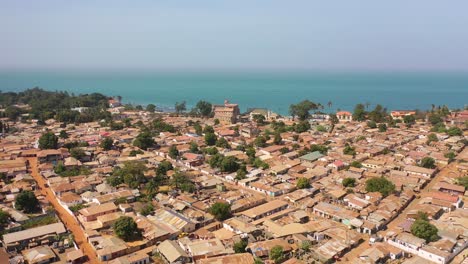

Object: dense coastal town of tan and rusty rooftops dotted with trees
[0,91,468,264]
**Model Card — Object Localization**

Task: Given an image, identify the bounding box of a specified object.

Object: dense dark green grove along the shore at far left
[0,87,111,123]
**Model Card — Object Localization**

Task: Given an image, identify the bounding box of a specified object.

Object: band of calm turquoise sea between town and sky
[0,72,468,114]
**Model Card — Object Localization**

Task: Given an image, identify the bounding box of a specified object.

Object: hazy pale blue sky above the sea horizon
[0,0,468,71]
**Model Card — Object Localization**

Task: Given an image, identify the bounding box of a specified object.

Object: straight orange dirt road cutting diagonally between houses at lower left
[28,158,100,264]
